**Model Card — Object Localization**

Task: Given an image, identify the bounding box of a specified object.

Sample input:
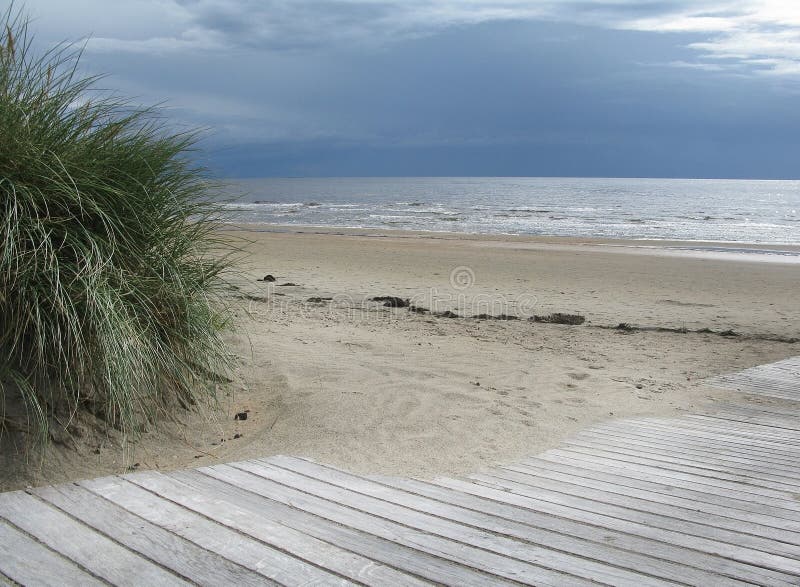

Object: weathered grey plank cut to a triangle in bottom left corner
[0,520,106,587]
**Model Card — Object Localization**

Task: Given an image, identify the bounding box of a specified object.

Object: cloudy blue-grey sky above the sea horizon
[15,0,800,178]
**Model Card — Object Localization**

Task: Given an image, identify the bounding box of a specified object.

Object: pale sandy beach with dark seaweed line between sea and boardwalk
[0,226,800,490]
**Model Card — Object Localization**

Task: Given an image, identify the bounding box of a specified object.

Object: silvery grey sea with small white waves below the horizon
[222,177,800,245]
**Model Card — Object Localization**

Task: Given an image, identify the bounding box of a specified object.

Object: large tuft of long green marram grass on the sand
[0,9,236,440]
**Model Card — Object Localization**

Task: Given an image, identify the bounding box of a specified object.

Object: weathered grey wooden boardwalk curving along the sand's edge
[0,359,800,587]
